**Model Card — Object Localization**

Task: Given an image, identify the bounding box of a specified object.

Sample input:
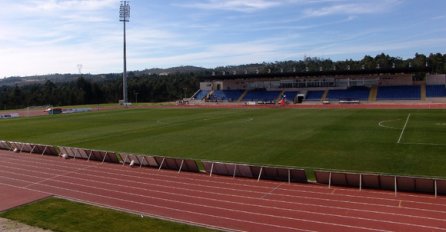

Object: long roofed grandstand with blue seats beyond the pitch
[194,68,446,103]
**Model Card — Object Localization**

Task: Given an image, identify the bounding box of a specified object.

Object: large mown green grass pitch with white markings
[0,109,446,177]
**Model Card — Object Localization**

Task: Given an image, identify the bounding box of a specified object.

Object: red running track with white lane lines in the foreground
[0,151,446,232]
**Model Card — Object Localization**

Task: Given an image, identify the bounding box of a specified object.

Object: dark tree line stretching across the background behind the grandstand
[0,53,446,109]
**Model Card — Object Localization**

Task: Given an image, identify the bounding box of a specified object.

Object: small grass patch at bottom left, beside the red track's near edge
[0,198,211,232]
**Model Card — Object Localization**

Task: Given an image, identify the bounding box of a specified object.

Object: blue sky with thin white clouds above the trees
[0,0,446,78]
